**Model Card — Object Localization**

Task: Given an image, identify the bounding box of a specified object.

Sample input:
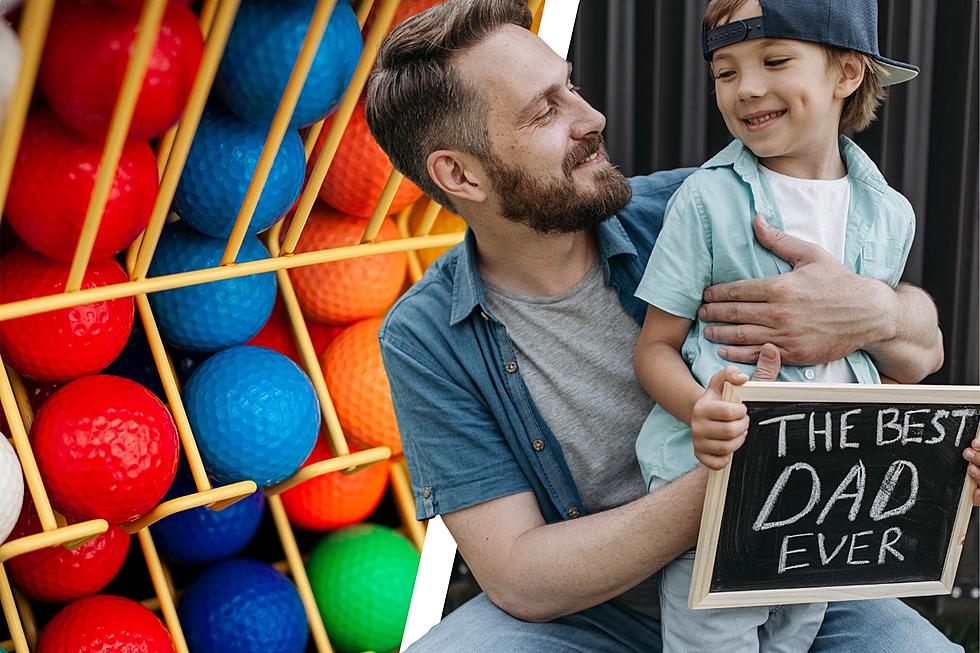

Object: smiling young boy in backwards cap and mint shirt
[635,0,917,653]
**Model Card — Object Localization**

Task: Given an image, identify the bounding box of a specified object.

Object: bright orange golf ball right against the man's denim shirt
[320,318,402,456]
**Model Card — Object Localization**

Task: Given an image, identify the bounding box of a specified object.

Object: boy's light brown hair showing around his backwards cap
[704,0,887,133]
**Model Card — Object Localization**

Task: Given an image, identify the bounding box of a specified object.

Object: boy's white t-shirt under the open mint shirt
[759,166,857,383]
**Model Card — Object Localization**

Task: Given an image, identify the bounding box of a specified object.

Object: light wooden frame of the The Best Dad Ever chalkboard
[688,382,980,609]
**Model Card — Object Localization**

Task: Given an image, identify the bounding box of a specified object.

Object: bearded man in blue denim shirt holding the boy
[367,0,980,652]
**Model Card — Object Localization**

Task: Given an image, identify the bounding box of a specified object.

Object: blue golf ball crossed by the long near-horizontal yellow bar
[149,222,276,351]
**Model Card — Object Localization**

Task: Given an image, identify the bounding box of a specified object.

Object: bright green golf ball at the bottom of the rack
[307,524,419,653]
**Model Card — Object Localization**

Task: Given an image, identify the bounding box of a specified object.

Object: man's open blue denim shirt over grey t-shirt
[379,169,693,522]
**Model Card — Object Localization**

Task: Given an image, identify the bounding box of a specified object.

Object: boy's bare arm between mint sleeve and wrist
[633,306,704,426]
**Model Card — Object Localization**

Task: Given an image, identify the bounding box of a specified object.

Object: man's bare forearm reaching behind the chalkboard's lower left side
[474,468,707,621]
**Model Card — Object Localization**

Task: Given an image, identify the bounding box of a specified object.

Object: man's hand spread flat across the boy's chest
[698,216,898,365]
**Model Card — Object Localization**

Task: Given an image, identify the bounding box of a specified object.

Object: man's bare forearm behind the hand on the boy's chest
[864,283,944,383]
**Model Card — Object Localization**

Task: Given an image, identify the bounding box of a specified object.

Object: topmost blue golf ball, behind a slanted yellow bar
[214,0,363,127]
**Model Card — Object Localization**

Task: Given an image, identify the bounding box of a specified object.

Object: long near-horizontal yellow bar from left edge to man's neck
[0,233,463,322]
